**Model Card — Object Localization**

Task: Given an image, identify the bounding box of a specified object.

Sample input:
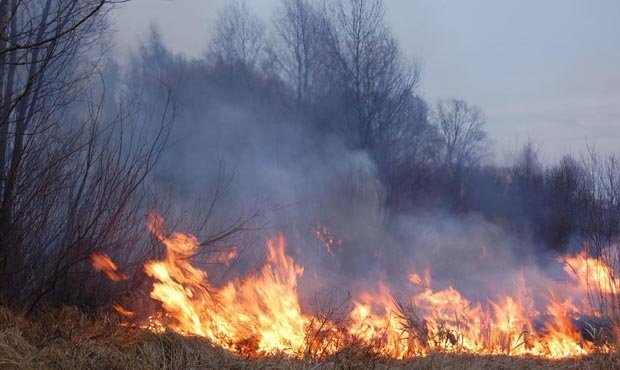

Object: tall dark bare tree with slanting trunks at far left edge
[0,0,115,298]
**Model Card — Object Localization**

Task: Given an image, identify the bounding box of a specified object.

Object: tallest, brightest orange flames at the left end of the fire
[145,215,310,355]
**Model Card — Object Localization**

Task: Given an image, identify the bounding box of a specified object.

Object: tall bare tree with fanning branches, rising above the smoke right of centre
[322,0,419,149]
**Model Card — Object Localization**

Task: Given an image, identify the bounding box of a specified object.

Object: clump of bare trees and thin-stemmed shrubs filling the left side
[0,0,175,307]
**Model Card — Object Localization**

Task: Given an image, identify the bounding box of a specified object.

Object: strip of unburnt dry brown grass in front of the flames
[0,307,620,369]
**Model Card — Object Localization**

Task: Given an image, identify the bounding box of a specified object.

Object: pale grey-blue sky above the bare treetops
[116,0,620,161]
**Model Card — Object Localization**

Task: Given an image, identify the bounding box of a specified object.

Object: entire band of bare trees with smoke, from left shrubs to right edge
[0,0,620,310]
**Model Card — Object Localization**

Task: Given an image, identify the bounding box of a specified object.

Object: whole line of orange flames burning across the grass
[93,214,617,358]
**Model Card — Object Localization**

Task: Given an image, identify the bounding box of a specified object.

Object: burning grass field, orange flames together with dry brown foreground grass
[12,214,620,369]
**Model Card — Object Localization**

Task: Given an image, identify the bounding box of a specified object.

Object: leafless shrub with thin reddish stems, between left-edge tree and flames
[23,82,175,308]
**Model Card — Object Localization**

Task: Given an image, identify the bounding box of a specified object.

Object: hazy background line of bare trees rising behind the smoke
[133,0,620,251]
